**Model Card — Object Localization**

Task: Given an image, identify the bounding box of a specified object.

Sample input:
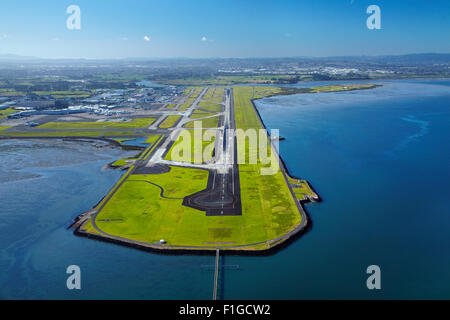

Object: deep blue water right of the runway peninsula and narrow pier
[229,80,450,299]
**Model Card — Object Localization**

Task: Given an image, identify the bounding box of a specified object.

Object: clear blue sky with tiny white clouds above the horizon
[0,0,450,59]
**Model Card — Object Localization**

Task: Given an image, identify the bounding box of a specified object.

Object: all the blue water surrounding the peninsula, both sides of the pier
[0,79,450,299]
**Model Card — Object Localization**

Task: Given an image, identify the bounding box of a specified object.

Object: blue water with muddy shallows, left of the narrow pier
[0,140,213,299]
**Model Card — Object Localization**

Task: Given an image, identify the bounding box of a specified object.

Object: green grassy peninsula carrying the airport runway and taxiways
[0,84,376,254]
